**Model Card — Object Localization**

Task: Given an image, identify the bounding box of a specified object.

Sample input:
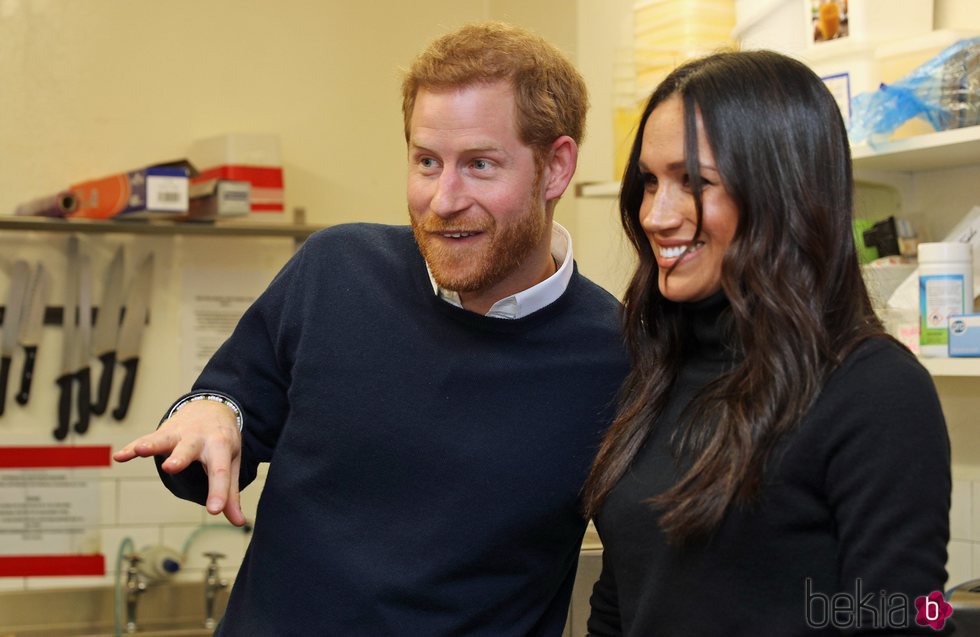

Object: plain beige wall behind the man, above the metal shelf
[0,0,630,289]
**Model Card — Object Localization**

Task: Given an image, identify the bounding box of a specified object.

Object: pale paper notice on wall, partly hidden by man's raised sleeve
[181,267,273,388]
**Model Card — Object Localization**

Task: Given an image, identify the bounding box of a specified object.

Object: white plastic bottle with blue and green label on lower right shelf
[919,242,973,356]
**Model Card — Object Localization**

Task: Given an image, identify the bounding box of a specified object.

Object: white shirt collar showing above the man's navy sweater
[425,222,574,319]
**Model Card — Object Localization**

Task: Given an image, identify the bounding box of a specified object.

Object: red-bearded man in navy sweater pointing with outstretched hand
[115,23,627,637]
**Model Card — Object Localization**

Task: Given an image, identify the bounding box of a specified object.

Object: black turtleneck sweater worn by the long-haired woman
[588,296,952,637]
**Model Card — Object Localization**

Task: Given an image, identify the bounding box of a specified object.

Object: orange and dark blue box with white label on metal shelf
[68,160,196,219]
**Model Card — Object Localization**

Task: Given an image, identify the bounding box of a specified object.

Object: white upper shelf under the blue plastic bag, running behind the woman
[575,126,980,199]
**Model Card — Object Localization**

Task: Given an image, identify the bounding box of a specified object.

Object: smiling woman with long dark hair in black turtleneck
[585,51,950,637]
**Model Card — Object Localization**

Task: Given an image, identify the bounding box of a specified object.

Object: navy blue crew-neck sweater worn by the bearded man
[162,224,627,637]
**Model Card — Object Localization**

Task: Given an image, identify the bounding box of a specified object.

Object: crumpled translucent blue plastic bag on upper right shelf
[848,37,980,146]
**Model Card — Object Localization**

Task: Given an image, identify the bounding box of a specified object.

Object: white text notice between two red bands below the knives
[0,468,101,555]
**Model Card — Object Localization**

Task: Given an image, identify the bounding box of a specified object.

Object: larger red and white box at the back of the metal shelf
[188,133,285,223]
